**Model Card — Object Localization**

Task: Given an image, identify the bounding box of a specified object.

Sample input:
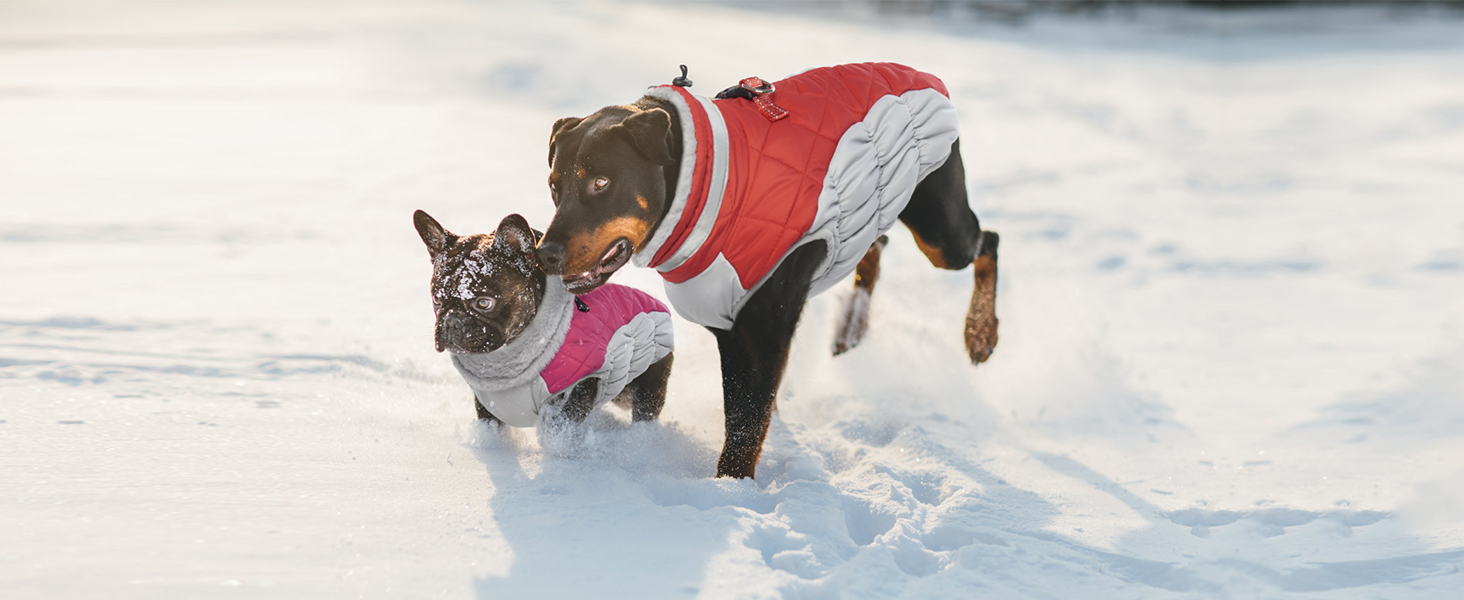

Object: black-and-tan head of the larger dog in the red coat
[537,107,672,294]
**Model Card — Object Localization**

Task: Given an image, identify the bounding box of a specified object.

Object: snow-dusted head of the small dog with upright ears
[417,211,545,354]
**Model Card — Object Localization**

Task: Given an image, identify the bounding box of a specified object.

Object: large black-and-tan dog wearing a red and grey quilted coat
[537,63,1000,477]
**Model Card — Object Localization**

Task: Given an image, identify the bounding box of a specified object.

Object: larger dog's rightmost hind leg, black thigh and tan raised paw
[900,139,1000,363]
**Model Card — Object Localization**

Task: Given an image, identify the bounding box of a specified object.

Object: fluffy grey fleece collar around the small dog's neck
[452,275,574,392]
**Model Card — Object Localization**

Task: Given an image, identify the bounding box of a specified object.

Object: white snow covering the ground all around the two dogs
[0,0,1464,599]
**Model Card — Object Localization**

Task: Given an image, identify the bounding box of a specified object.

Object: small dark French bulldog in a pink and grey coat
[413,211,675,427]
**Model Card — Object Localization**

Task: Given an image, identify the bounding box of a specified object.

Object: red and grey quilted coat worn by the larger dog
[635,63,960,329]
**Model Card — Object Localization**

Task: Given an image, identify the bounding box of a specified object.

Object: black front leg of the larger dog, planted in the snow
[707,240,829,477]
